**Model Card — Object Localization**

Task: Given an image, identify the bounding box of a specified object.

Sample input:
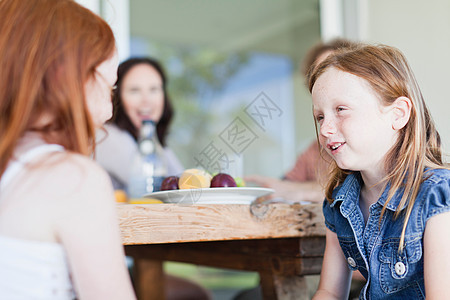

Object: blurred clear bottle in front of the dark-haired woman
[127,120,167,199]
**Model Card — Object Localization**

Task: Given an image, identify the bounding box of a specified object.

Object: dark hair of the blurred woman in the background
[109,57,173,146]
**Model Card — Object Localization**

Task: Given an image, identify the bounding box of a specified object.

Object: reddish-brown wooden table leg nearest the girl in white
[133,258,166,300]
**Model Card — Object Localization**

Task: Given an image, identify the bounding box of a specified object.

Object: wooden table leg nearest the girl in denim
[259,272,309,300]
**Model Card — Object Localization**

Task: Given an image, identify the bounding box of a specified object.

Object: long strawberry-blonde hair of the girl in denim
[309,44,445,251]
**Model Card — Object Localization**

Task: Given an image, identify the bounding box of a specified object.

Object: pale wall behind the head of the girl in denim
[362,0,450,161]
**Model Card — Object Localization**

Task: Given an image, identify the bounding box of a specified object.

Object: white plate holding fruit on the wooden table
[144,187,274,204]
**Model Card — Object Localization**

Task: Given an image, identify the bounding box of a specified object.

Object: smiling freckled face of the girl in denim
[312,68,397,182]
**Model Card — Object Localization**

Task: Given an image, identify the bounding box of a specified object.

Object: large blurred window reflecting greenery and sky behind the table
[130,0,320,176]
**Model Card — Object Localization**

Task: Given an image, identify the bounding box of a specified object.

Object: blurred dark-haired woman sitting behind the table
[96,58,210,300]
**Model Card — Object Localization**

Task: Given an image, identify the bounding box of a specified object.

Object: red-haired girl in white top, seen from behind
[0,0,135,299]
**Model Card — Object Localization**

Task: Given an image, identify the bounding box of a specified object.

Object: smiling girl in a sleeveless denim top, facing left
[309,45,450,299]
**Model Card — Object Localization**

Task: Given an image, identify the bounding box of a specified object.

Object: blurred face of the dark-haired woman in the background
[120,63,164,129]
